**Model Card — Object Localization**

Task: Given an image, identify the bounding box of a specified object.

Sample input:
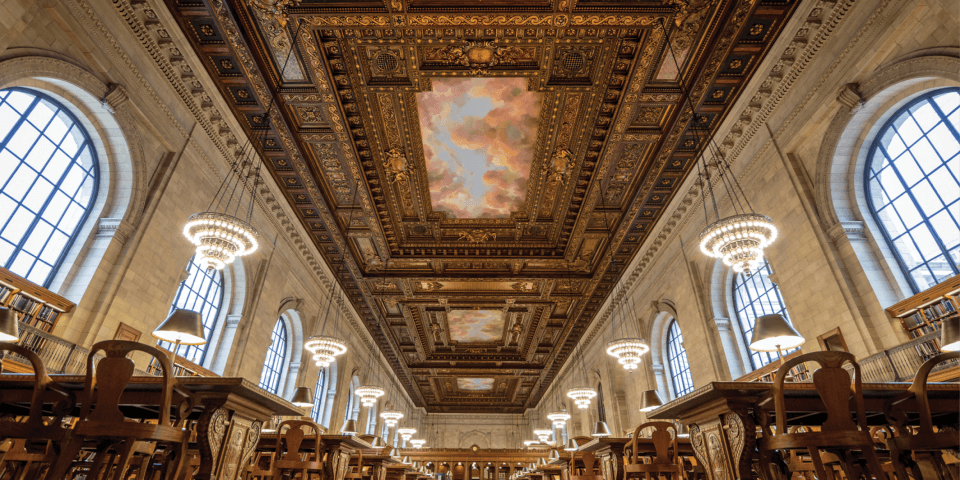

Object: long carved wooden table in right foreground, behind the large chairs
[647,382,960,480]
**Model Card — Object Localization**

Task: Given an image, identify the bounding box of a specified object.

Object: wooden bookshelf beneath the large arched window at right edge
[887,275,960,346]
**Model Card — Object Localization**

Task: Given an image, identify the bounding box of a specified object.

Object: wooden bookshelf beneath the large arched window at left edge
[0,268,76,332]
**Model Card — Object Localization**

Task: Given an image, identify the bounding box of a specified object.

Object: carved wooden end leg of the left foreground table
[194,406,264,480]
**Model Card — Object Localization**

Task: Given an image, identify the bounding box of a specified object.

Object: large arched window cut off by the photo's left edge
[0,88,99,286]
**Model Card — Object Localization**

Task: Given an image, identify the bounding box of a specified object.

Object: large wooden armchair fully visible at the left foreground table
[47,340,193,480]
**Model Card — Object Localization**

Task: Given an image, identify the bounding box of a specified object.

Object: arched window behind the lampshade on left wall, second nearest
[158,256,223,365]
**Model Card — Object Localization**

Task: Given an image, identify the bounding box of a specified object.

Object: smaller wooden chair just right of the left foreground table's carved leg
[271,420,326,480]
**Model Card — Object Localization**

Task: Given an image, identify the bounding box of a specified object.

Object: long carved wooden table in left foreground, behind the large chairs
[0,375,304,480]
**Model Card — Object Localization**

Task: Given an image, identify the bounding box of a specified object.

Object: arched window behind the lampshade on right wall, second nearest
[733,259,790,369]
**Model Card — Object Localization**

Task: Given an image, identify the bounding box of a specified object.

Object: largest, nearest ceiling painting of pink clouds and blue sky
[417,78,543,218]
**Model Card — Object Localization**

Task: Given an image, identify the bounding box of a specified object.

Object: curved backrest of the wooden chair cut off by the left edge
[0,342,76,435]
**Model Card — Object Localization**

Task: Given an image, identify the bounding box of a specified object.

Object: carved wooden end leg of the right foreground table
[690,411,756,480]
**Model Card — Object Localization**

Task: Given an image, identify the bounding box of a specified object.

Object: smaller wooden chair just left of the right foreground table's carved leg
[623,422,683,480]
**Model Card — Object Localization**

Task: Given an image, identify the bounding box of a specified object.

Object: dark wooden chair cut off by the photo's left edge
[0,343,76,480]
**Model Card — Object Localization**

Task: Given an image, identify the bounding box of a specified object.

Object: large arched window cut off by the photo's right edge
[864,88,960,293]
